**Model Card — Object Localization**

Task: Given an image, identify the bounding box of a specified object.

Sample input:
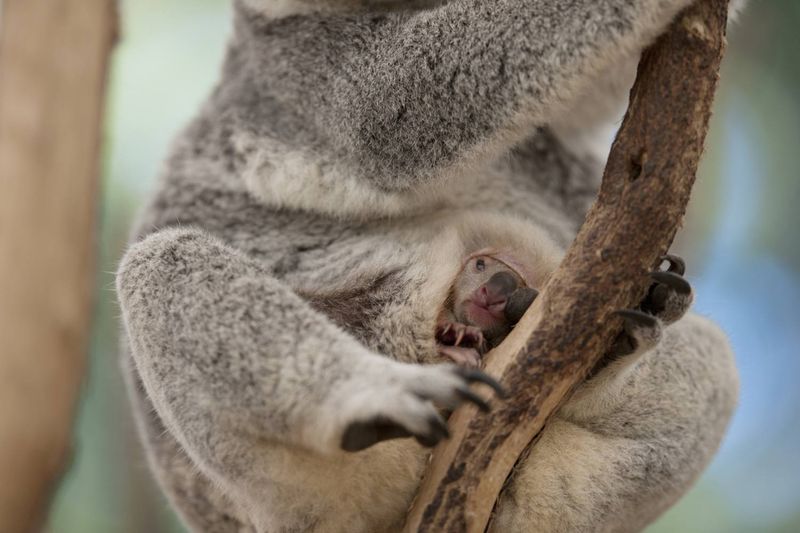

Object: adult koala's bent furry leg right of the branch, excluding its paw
[492,315,738,533]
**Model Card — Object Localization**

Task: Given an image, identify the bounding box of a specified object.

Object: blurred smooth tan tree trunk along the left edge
[0,0,116,533]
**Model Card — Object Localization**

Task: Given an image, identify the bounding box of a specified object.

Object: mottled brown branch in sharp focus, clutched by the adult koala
[405,0,728,533]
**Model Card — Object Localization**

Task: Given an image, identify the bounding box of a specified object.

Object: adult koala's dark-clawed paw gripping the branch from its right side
[611,255,693,356]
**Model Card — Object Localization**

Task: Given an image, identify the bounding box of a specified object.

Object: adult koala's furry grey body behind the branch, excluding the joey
[117,0,737,533]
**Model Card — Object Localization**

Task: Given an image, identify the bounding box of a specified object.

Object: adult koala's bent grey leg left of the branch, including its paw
[117,230,496,483]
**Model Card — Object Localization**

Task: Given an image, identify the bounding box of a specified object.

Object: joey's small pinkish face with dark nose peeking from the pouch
[453,255,525,342]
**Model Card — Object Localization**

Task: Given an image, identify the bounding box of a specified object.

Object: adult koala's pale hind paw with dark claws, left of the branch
[340,364,504,452]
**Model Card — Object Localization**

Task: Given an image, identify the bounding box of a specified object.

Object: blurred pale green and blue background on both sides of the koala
[49,0,800,533]
